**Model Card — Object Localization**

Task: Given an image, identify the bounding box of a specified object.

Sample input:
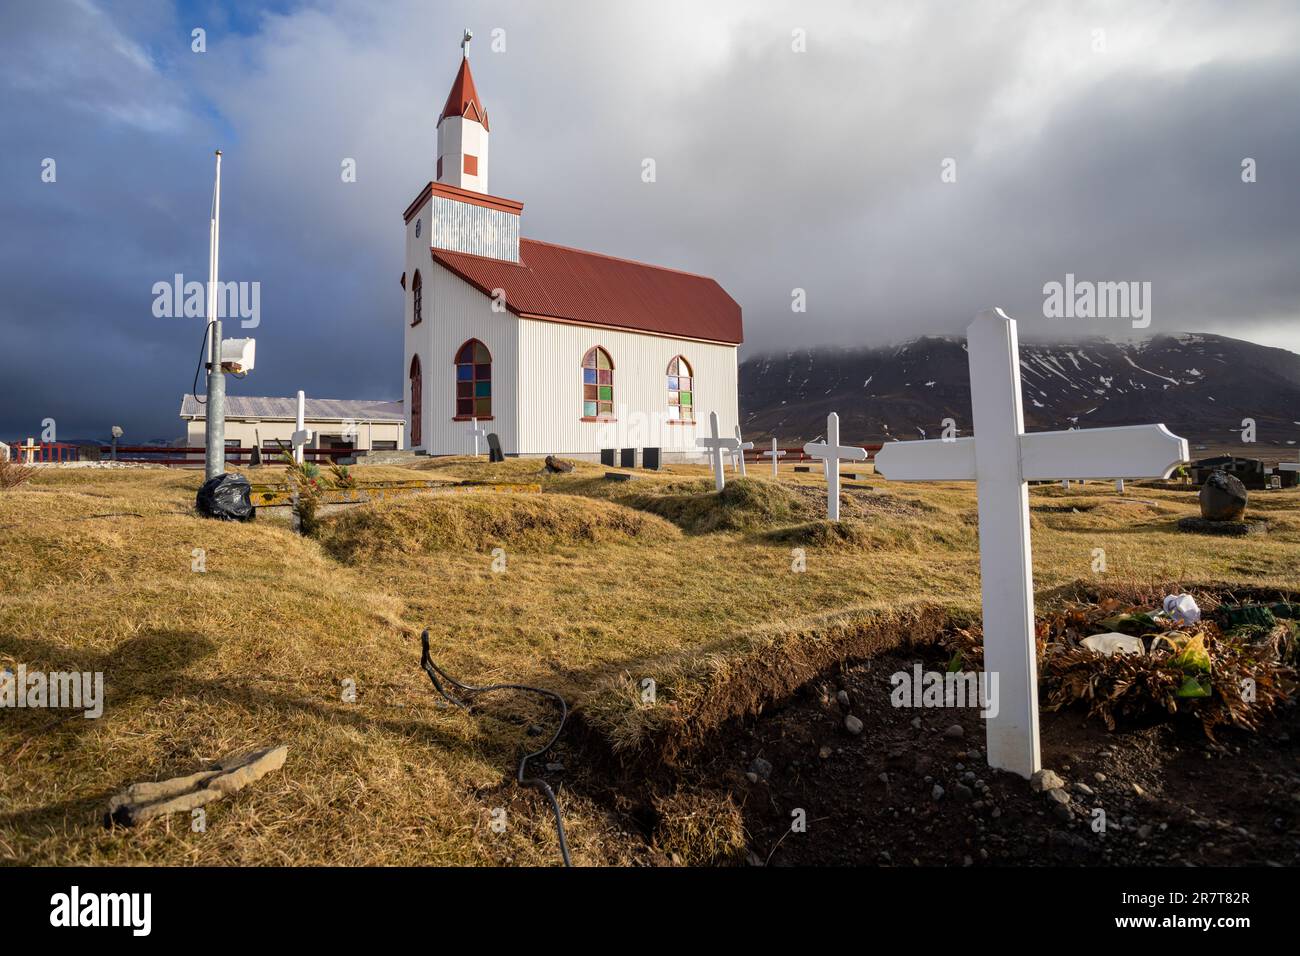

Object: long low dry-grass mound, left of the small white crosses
[320,494,679,564]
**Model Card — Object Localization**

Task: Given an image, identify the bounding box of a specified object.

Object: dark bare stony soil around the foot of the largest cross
[681,648,1300,866]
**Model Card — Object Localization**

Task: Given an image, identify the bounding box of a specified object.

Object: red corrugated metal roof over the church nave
[430,239,744,345]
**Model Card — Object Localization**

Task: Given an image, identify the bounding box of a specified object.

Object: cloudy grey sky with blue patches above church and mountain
[0,0,1300,440]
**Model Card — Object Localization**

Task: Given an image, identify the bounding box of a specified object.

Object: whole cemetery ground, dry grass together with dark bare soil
[0,459,1300,865]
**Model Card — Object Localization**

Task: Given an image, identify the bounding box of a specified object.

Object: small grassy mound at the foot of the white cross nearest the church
[627,477,815,535]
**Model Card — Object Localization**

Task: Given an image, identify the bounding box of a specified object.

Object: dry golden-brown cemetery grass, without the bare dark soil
[0,459,1300,865]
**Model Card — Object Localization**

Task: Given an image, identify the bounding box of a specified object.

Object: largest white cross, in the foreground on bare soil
[876,308,1187,777]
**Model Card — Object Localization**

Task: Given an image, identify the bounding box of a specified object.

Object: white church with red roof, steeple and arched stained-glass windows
[402,41,742,462]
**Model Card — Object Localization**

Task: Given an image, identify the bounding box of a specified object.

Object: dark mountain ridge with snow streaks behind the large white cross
[740,332,1300,454]
